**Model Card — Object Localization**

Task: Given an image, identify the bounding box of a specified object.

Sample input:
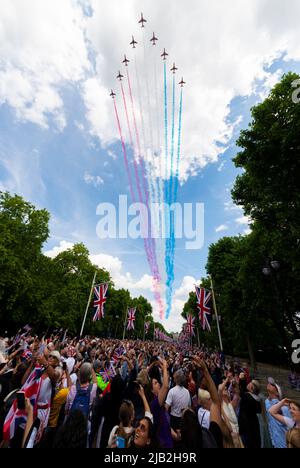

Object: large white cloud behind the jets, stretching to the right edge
[81,0,300,180]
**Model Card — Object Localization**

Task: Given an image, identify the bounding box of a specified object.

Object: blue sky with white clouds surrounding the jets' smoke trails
[0,0,300,331]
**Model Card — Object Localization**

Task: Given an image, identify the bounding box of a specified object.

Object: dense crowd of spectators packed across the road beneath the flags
[0,329,300,452]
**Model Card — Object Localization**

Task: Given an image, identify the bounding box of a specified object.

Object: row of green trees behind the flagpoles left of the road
[0,193,164,338]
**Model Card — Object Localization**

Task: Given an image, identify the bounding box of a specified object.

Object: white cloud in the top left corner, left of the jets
[0,0,91,131]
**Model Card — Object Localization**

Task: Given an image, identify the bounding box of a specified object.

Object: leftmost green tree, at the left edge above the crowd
[0,192,49,327]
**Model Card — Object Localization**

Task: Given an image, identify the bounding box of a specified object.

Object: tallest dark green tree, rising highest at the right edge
[232,73,300,340]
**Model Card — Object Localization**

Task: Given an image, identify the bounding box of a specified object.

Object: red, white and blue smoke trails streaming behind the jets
[111,14,185,319]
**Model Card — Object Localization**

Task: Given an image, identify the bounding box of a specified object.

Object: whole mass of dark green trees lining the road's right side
[184,73,300,363]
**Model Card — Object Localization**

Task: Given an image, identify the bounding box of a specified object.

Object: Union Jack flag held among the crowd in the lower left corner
[3,367,42,441]
